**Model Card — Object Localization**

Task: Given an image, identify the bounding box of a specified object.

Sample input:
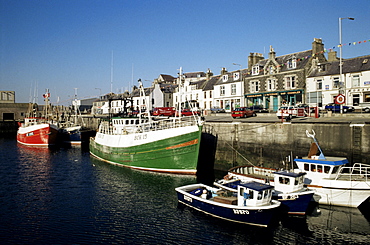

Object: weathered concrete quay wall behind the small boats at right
[201,113,370,171]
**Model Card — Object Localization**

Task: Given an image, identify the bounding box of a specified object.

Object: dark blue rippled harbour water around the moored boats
[0,137,370,244]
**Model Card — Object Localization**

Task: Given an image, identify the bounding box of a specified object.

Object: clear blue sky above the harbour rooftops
[0,0,370,105]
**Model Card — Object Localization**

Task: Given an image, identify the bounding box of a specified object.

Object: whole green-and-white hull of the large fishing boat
[89,126,202,174]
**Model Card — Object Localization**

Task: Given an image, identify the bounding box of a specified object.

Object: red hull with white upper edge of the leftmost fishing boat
[17,123,58,146]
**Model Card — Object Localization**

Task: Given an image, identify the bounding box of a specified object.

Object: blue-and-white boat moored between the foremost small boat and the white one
[214,165,315,215]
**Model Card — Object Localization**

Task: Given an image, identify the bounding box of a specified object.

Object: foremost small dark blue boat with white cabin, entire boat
[175,182,280,227]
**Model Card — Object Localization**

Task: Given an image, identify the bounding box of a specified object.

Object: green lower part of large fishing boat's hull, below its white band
[90,126,202,174]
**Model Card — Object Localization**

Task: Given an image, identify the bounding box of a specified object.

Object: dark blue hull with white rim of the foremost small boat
[175,188,280,227]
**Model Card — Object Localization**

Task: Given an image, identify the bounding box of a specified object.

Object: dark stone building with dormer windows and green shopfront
[244,38,326,111]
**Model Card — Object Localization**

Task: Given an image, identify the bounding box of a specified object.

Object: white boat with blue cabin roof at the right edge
[294,130,370,207]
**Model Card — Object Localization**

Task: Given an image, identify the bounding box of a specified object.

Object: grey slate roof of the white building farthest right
[308,55,370,77]
